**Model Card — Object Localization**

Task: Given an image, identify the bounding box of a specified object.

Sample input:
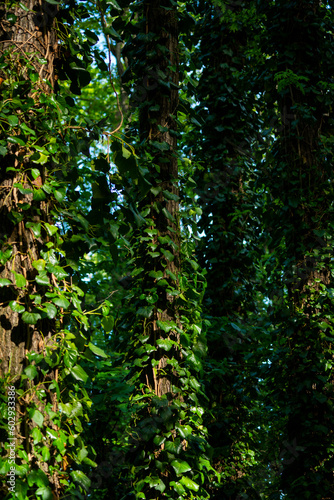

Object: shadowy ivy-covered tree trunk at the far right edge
[262,0,334,500]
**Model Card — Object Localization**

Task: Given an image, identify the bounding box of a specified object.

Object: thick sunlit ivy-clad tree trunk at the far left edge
[0,0,59,498]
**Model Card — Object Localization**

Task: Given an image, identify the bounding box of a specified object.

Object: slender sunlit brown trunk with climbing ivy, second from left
[139,0,180,396]
